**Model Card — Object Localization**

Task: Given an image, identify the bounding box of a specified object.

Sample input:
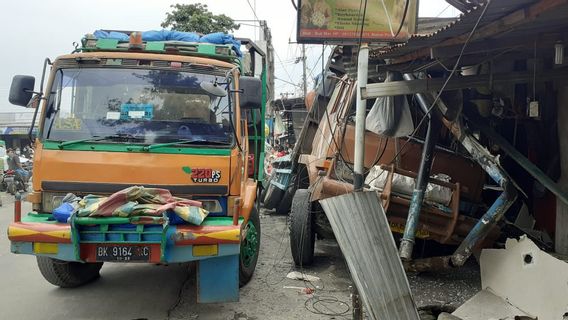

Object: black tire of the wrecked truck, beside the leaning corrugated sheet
[290,189,316,266]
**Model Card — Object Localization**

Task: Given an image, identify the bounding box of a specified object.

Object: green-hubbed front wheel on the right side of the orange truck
[239,204,260,287]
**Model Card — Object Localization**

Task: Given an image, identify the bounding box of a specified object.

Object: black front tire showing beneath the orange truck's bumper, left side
[36,256,103,288]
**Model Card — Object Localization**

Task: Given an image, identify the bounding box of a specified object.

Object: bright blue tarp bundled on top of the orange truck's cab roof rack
[94,30,242,57]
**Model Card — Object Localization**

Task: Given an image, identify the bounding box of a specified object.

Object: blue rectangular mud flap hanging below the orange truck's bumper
[197,254,239,303]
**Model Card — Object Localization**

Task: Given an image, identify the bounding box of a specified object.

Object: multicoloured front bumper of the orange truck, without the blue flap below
[8,213,241,263]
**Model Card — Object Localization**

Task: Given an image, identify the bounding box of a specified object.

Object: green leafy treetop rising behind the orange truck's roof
[161,3,240,34]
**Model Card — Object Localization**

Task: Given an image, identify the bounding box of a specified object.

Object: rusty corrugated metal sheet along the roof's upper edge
[371,0,538,59]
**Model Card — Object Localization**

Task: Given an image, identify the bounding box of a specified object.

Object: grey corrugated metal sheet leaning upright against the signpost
[320,192,420,320]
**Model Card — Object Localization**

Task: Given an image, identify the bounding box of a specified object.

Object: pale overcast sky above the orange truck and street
[0,0,459,112]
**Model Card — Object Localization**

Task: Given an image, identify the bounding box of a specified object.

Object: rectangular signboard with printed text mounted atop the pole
[297,0,418,43]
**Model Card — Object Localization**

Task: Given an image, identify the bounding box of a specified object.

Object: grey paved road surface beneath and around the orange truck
[0,193,356,320]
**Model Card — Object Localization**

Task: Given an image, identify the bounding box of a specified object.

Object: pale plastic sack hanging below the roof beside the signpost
[365,73,414,137]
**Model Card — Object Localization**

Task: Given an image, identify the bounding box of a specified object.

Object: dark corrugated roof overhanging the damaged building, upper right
[370,0,568,70]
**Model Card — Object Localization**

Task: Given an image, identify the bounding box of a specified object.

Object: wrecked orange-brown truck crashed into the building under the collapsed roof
[282,37,563,271]
